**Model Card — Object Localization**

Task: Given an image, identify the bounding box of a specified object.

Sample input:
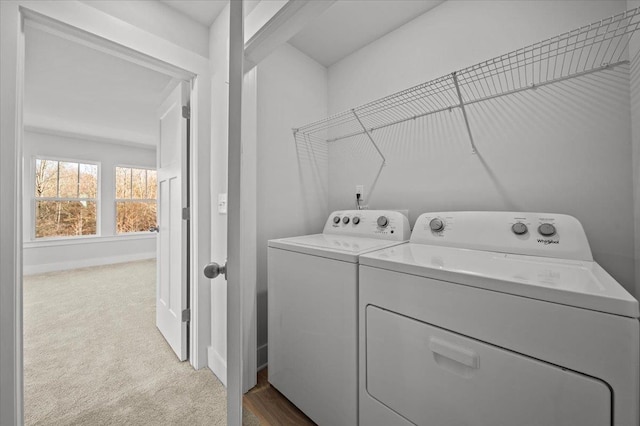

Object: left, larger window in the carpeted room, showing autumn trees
[35,158,98,238]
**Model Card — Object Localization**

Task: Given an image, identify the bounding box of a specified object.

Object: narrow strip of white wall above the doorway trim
[82,0,209,57]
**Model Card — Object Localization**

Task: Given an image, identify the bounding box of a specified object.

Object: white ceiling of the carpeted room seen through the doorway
[24,26,175,145]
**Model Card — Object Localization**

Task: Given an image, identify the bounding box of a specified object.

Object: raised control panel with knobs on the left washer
[322,210,411,241]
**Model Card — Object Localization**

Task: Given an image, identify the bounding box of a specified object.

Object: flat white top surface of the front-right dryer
[360,243,640,318]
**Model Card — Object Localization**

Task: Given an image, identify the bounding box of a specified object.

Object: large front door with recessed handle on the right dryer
[364,306,611,426]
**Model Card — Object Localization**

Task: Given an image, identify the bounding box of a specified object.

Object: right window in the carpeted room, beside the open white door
[116,167,158,234]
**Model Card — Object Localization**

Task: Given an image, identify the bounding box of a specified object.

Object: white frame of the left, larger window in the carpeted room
[29,154,102,242]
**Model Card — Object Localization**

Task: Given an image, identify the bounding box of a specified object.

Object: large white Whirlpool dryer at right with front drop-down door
[359,212,640,426]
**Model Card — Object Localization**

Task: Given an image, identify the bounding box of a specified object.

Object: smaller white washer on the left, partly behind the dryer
[268,210,410,426]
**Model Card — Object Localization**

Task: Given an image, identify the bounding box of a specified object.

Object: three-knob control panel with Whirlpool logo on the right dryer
[411,212,593,261]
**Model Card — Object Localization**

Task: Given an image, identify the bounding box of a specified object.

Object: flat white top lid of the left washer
[269,234,404,263]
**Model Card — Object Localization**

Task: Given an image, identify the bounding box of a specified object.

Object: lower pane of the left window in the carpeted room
[36,201,96,238]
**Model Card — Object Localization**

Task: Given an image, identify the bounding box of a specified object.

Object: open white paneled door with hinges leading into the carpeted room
[156,82,189,361]
